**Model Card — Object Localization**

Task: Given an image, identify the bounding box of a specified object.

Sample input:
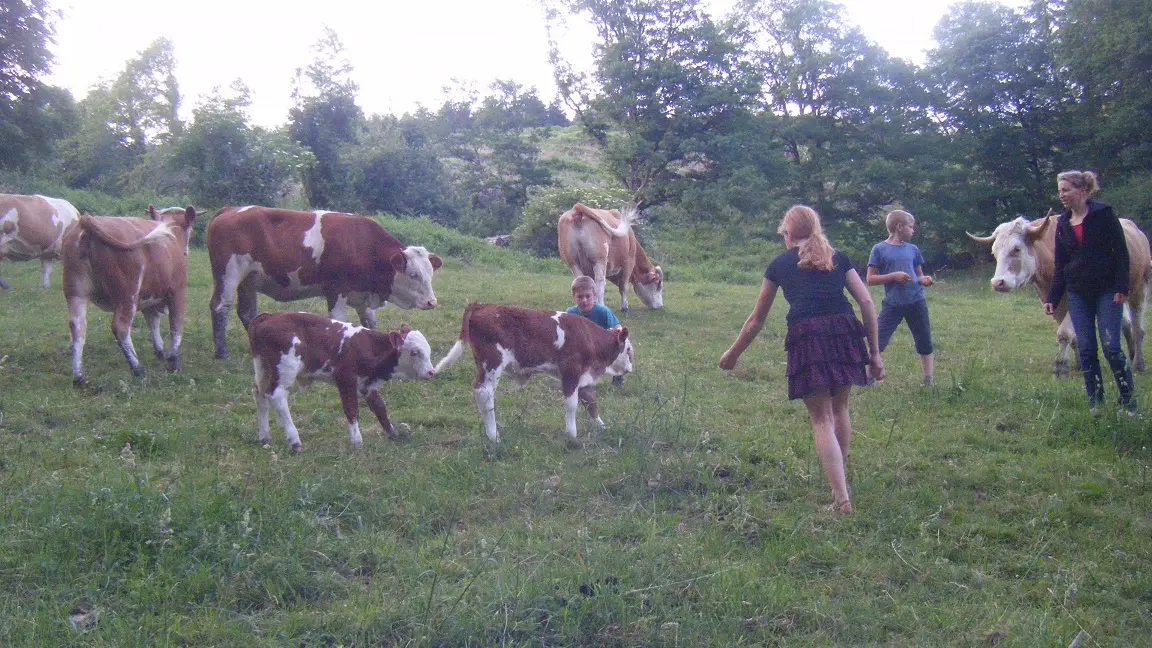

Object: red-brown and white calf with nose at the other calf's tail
[248,312,435,452]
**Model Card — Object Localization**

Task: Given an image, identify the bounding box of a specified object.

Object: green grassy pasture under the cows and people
[0,229,1152,647]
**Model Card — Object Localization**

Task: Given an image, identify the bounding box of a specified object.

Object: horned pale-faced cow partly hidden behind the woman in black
[968,214,1152,377]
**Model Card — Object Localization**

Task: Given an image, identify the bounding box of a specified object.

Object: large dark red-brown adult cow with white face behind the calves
[207,205,442,357]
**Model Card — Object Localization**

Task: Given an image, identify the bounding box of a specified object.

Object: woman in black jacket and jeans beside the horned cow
[1044,171,1136,414]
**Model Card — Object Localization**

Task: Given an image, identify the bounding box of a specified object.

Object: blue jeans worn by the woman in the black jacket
[1068,291,1132,407]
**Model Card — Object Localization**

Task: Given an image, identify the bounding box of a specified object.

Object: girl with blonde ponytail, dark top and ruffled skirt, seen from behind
[720,205,884,515]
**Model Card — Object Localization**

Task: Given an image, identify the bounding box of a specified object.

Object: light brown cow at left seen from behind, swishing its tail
[61,206,196,385]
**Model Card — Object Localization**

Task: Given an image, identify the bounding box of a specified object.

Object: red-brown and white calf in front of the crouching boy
[435,303,635,443]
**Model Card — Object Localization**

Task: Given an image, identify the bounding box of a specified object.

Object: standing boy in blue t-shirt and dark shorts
[867,210,934,386]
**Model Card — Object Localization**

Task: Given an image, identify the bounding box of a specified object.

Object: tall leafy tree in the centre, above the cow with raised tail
[550,0,759,206]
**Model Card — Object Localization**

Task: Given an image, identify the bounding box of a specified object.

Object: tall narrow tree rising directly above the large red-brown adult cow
[288,27,364,211]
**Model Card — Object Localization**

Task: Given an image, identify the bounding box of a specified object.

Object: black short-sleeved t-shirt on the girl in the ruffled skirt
[764,248,855,326]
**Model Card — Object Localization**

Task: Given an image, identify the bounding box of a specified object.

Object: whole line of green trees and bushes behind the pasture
[0,0,1152,262]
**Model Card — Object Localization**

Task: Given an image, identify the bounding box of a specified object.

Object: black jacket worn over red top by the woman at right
[1047,199,1128,303]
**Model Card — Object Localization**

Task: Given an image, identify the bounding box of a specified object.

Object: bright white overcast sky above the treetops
[42,0,1018,126]
